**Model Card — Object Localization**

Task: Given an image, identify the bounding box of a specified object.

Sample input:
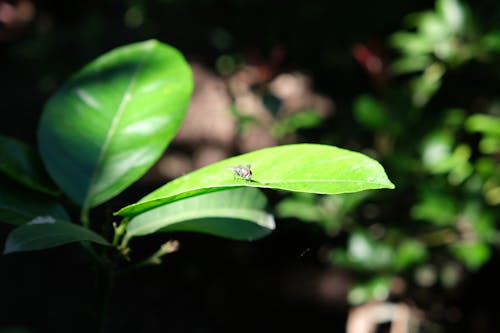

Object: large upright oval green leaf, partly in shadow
[38,40,193,207]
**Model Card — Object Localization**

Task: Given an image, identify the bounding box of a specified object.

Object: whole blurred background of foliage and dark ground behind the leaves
[0,0,500,333]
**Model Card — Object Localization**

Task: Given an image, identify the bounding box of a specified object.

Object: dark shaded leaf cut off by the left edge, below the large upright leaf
[0,135,58,194]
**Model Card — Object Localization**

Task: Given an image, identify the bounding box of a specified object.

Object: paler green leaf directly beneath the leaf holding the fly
[125,188,274,240]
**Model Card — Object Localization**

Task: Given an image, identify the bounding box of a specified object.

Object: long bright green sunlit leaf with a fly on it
[117,144,394,216]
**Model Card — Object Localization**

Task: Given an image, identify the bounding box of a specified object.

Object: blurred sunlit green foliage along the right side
[277,0,500,304]
